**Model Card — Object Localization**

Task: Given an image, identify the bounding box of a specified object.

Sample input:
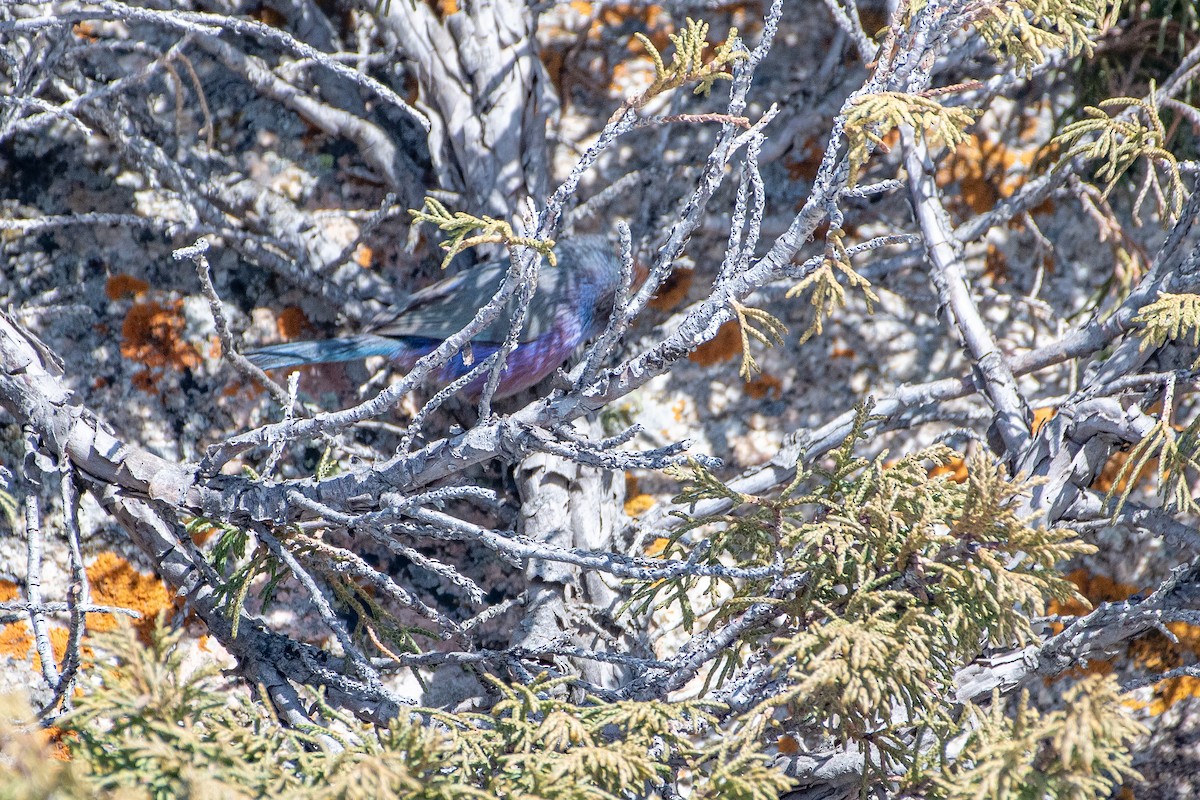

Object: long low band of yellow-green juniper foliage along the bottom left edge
[0,626,788,800]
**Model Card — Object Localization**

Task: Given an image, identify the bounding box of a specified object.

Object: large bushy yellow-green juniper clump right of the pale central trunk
[635,411,1094,771]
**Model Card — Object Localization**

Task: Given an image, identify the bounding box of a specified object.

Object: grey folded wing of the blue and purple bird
[372,260,568,343]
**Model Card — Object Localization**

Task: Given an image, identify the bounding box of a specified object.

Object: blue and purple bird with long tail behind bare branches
[246,235,620,399]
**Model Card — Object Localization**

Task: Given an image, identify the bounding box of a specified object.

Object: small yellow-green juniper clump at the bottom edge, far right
[929,675,1146,800]
